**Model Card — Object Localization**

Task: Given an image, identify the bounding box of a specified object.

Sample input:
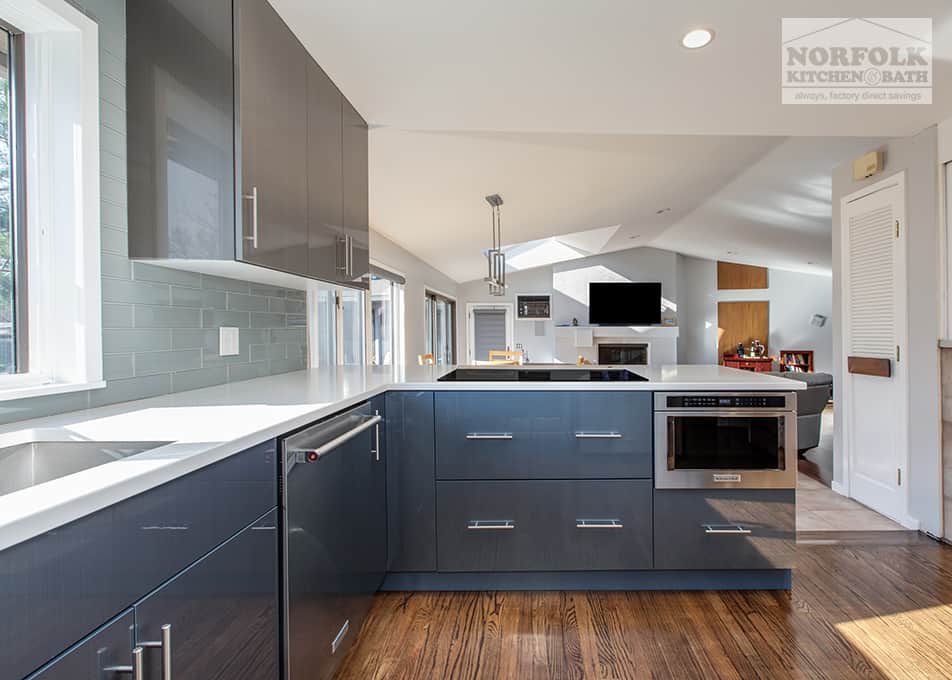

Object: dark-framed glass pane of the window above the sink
[0,28,29,374]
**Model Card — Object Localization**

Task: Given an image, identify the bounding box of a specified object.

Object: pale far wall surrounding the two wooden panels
[678,256,833,373]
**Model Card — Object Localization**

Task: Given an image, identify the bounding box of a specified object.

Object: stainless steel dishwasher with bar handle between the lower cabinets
[281,403,387,680]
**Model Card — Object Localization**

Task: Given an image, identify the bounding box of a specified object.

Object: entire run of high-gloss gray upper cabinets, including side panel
[126,0,369,288]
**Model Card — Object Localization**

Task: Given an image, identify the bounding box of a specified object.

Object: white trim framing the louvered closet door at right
[834,172,919,529]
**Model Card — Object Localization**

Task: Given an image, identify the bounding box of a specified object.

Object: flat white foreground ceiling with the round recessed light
[271,0,952,137]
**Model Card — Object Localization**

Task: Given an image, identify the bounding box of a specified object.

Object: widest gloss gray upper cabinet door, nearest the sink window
[235,0,309,273]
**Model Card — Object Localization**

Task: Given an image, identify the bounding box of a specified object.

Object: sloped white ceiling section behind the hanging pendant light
[370,128,783,281]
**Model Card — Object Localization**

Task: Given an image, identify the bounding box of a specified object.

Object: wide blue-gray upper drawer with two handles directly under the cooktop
[435,392,652,479]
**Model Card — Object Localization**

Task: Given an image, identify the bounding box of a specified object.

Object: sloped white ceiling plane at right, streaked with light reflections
[651,137,883,274]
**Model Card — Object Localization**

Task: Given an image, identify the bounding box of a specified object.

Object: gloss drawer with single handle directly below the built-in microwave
[654,489,796,569]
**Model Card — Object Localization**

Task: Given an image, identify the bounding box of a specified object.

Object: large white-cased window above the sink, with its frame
[0,0,105,400]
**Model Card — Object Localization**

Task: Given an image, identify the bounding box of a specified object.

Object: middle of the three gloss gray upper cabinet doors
[307,59,346,279]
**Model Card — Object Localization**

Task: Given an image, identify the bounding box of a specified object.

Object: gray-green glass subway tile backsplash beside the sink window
[0,0,306,423]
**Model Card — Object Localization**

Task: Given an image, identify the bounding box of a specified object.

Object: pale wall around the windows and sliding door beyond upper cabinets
[370,230,466,364]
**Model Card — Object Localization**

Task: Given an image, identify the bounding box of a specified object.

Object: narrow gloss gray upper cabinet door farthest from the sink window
[343,99,370,281]
